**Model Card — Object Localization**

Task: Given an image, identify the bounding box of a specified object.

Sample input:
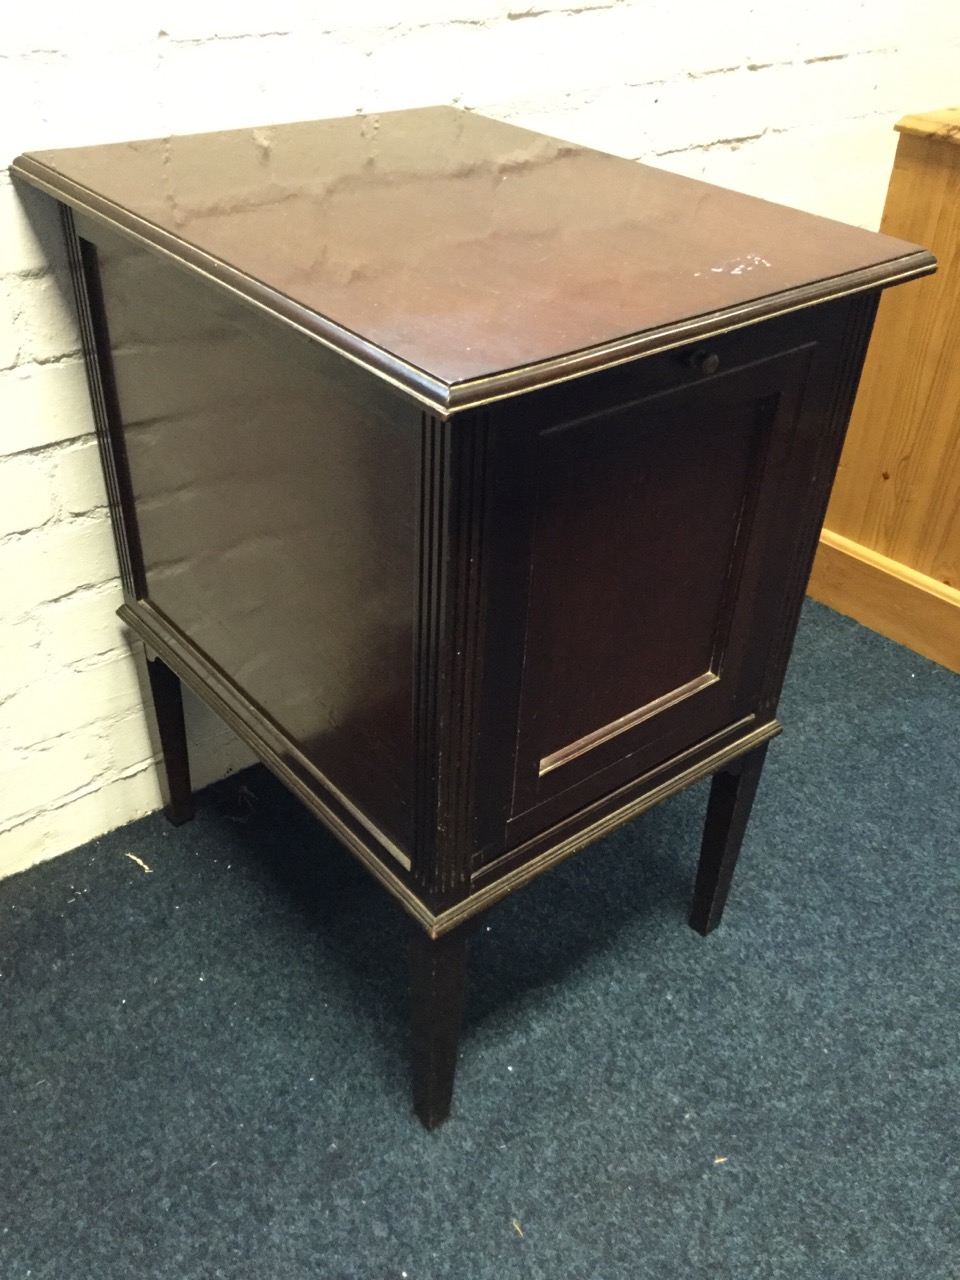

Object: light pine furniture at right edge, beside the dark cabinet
[809,108,960,671]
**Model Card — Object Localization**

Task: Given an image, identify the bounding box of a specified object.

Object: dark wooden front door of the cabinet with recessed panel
[513,347,812,815]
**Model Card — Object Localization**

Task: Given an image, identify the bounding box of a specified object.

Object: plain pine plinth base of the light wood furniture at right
[806,529,960,672]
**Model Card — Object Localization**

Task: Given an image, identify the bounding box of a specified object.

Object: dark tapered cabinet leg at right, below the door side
[690,742,767,934]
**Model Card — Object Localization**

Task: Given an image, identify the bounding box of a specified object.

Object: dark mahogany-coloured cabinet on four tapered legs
[14,108,934,1125]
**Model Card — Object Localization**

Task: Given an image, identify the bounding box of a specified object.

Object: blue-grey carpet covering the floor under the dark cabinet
[0,604,960,1280]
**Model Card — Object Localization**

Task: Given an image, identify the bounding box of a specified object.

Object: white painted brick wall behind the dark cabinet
[0,0,960,874]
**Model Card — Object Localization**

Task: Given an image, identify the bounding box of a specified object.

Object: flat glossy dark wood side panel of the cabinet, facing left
[92,230,420,851]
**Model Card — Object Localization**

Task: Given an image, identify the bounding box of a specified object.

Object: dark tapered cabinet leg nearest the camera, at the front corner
[410,920,477,1129]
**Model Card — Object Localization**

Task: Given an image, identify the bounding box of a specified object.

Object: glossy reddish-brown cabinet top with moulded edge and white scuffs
[13,108,933,408]
